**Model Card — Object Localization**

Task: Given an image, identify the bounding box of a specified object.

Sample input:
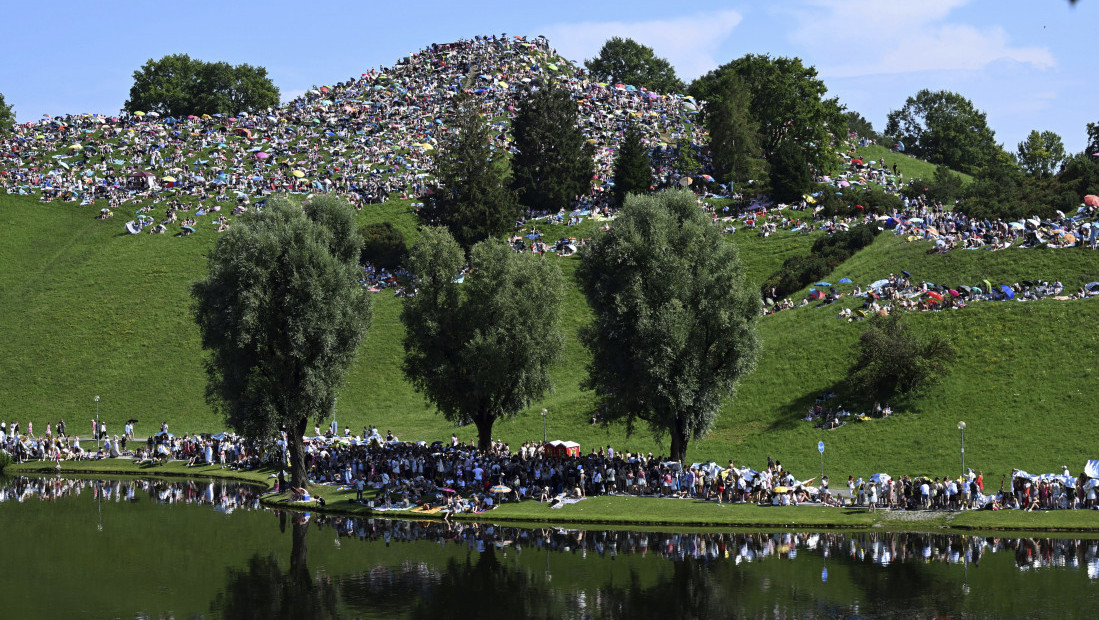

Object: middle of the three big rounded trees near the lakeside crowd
[401,226,564,451]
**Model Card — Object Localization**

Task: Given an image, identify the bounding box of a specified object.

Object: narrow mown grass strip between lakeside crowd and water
[4,458,1099,535]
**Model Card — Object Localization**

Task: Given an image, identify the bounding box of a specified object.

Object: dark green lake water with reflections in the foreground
[0,478,1099,619]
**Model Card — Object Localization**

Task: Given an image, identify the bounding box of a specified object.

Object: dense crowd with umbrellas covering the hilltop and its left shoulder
[0,36,704,232]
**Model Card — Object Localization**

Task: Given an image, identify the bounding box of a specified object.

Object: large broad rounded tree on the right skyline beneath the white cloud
[885,89,1002,174]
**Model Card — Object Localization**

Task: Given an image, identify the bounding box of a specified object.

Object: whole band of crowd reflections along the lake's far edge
[8,477,1099,578]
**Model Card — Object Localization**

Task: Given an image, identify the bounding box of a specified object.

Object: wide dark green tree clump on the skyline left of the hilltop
[123,54,279,117]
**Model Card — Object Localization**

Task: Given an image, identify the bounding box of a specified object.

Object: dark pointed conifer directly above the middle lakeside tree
[420,99,519,251]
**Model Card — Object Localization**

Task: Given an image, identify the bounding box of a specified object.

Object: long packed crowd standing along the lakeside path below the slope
[0,423,1099,517]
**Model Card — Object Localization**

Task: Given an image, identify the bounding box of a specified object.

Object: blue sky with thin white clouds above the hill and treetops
[0,0,1099,152]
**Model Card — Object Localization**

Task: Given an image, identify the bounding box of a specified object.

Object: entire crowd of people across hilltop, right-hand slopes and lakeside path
[0,36,1099,532]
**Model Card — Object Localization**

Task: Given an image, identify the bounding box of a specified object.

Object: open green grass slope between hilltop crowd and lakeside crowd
[0,192,1099,477]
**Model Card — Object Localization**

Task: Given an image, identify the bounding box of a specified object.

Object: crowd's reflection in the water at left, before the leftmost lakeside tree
[0,477,263,513]
